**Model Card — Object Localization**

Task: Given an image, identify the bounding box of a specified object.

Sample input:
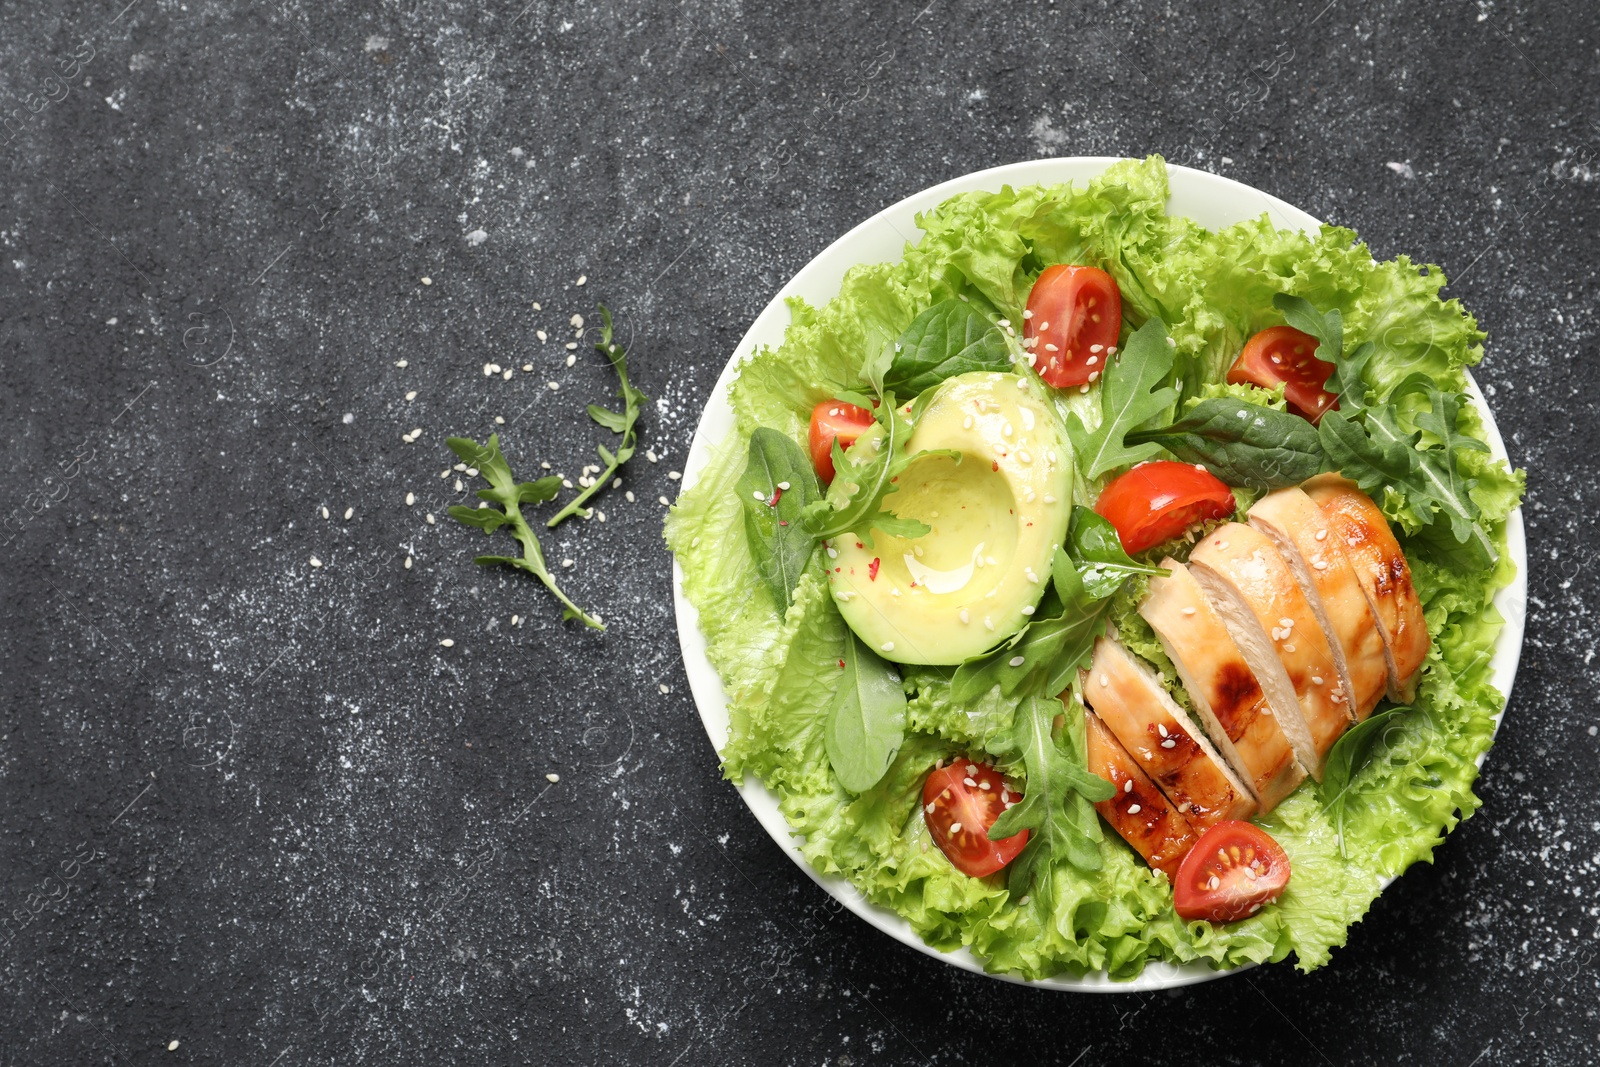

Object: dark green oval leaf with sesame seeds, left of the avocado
[733,426,822,614]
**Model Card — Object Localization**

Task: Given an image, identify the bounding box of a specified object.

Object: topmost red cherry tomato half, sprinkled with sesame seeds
[1022,264,1122,389]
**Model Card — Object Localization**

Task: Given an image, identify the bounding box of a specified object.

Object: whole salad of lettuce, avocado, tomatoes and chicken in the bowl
[667,157,1523,979]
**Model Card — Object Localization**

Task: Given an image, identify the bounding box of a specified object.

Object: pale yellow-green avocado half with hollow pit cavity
[824,371,1072,664]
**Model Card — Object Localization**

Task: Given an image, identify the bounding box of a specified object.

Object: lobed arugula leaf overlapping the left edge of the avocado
[802,399,962,547]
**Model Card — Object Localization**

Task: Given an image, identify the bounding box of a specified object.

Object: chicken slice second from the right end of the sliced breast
[1250,486,1389,721]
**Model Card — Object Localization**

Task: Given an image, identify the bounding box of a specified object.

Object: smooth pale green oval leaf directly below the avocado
[822,630,906,793]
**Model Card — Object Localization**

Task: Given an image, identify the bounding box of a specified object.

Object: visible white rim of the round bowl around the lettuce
[672,155,1528,992]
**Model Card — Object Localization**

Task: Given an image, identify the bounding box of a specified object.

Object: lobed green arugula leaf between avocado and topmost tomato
[1067,315,1178,480]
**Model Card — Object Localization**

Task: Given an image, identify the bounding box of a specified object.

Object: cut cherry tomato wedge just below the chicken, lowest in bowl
[1173,819,1290,923]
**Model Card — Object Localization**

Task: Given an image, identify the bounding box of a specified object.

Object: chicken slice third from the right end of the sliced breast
[1189,523,1354,782]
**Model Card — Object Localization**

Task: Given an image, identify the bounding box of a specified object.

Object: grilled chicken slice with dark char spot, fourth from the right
[1139,560,1306,814]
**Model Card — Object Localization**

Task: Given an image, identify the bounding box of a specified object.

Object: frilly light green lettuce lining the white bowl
[667,157,1523,977]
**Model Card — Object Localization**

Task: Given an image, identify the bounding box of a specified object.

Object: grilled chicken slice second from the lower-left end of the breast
[1083,637,1256,830]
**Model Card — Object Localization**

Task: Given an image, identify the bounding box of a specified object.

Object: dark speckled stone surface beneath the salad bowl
[0,0,1600,1067]
